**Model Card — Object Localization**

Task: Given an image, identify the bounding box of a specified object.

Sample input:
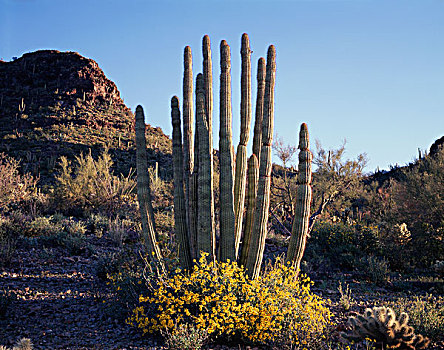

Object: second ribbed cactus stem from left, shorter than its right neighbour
[171,96,192,271]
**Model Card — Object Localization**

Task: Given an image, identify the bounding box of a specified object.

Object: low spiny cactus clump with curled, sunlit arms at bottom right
[341,307,430,350]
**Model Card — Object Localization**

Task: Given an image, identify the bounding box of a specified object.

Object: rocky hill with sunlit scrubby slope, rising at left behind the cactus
[0,50,171,183]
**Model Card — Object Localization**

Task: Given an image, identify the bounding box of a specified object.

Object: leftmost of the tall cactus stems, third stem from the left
[182,46,195,252]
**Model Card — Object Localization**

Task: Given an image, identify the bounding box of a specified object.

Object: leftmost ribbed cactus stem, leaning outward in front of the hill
[135,106,163,268]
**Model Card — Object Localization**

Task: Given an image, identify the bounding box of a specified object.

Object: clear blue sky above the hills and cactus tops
[0,0,444,172]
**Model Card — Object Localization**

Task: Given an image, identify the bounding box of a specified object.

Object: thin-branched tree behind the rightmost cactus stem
[272,137,368,232]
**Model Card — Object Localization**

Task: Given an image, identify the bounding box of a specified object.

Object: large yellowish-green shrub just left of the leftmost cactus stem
[53,150,136,215]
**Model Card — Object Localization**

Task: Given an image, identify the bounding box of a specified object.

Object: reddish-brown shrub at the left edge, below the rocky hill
[0,153,44,211]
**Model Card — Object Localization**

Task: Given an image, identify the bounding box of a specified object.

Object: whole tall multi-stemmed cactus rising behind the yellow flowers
[136,34,311,277]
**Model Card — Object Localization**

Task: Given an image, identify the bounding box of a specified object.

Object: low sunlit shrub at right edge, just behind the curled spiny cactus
[390,295,444,340]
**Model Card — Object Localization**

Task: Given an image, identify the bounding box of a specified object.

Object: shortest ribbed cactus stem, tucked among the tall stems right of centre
[239,154,259,266]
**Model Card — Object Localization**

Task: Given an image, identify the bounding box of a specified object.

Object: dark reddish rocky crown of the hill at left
[0,50,130,124]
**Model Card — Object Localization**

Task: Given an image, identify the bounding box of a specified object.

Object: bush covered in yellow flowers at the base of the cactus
[128,254,331,345]
